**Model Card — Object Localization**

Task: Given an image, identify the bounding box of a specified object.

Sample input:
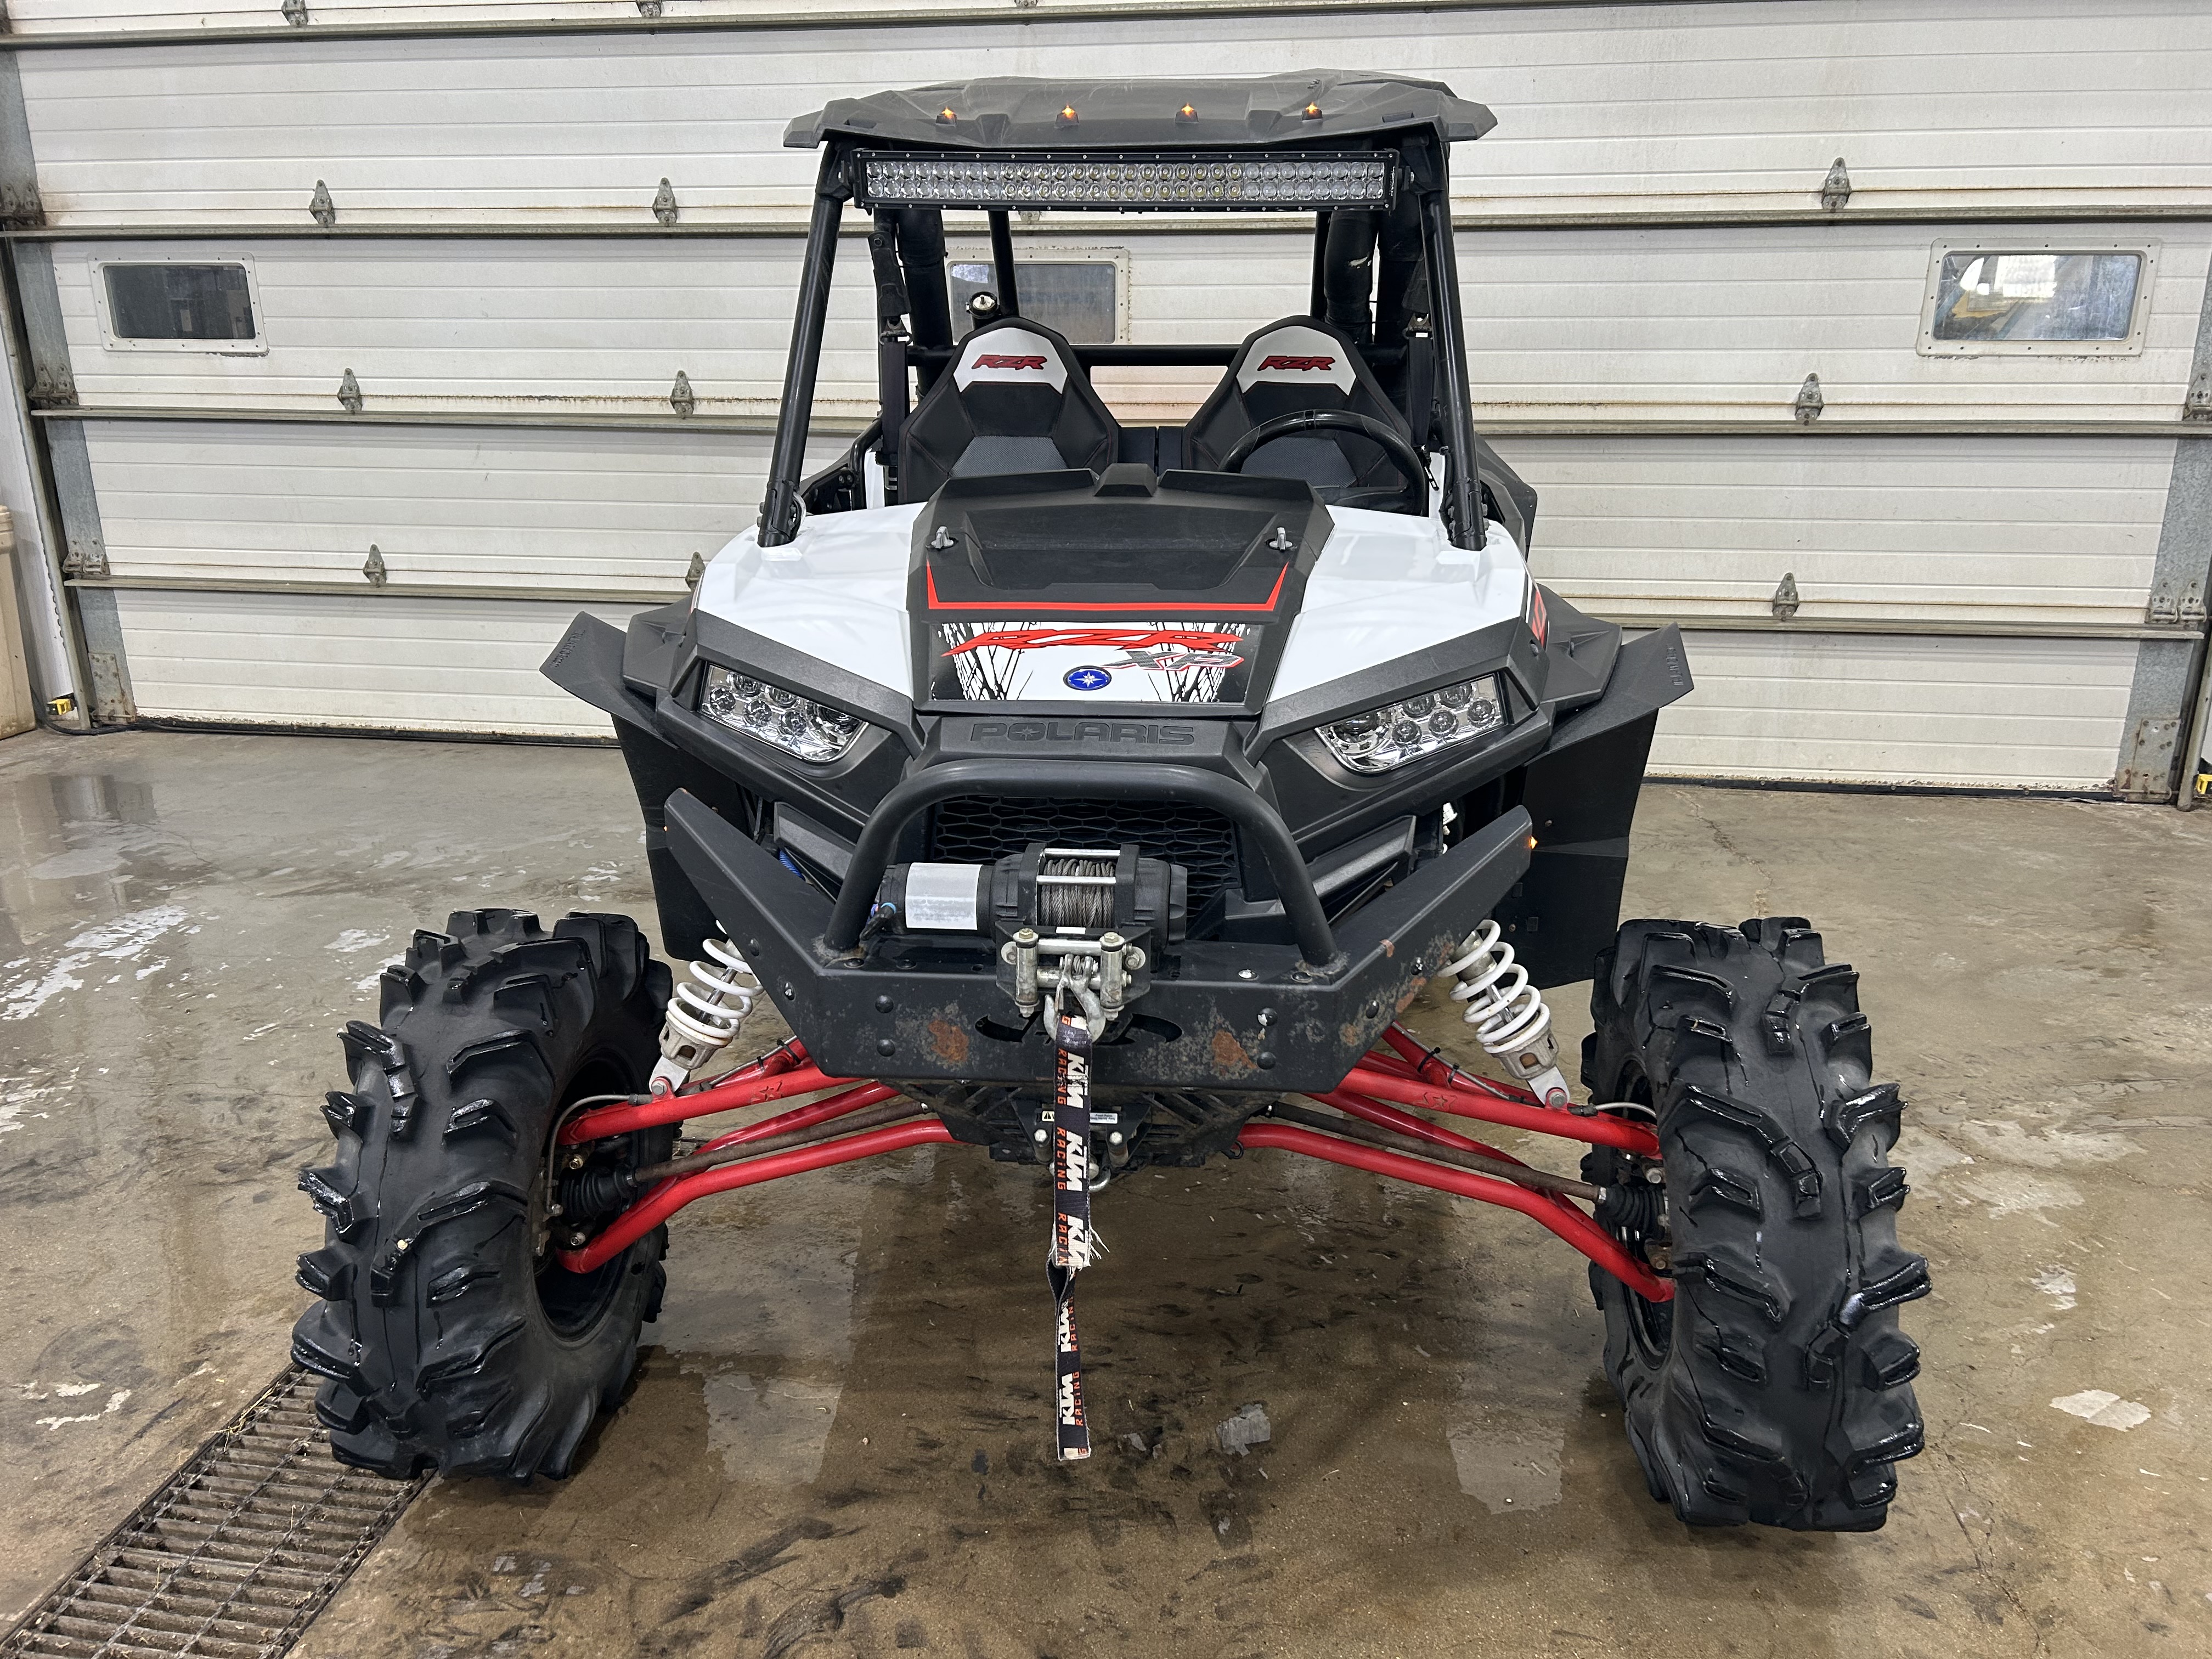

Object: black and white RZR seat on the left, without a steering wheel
[898,317,1121,502]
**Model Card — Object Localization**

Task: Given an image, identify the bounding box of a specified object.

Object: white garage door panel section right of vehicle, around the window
[1460,223,2212,420]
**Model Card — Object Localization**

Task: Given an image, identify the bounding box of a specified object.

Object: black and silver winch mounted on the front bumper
[870,840,1190,1024]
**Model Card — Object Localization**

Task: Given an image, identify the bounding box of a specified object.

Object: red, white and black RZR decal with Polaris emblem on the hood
[929,622,1259,703]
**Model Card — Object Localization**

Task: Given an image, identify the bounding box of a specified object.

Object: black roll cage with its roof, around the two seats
[759,73,1526,546]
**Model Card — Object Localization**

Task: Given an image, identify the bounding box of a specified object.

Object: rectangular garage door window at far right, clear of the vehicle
[1920,244,2152,356]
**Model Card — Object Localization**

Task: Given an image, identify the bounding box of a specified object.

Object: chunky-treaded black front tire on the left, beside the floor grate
[292,909,675,1480]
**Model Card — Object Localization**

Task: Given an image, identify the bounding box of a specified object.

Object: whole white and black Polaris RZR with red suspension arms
[294,73,1927,1528]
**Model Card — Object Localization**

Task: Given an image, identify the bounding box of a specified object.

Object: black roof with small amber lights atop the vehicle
[783,69,1498,150]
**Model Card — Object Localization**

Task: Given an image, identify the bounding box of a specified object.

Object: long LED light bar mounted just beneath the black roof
[856,150,1398,212]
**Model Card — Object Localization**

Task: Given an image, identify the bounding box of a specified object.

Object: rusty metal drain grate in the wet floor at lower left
[0,1365,422,1659]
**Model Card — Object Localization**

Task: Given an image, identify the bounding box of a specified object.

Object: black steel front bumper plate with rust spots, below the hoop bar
[668,774,1531,1093]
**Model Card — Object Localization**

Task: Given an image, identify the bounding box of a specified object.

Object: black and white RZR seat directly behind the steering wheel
[1183,317,1413,500]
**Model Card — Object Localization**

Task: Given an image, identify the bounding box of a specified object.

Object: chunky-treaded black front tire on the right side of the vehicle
[1582,916,1929,1533]
